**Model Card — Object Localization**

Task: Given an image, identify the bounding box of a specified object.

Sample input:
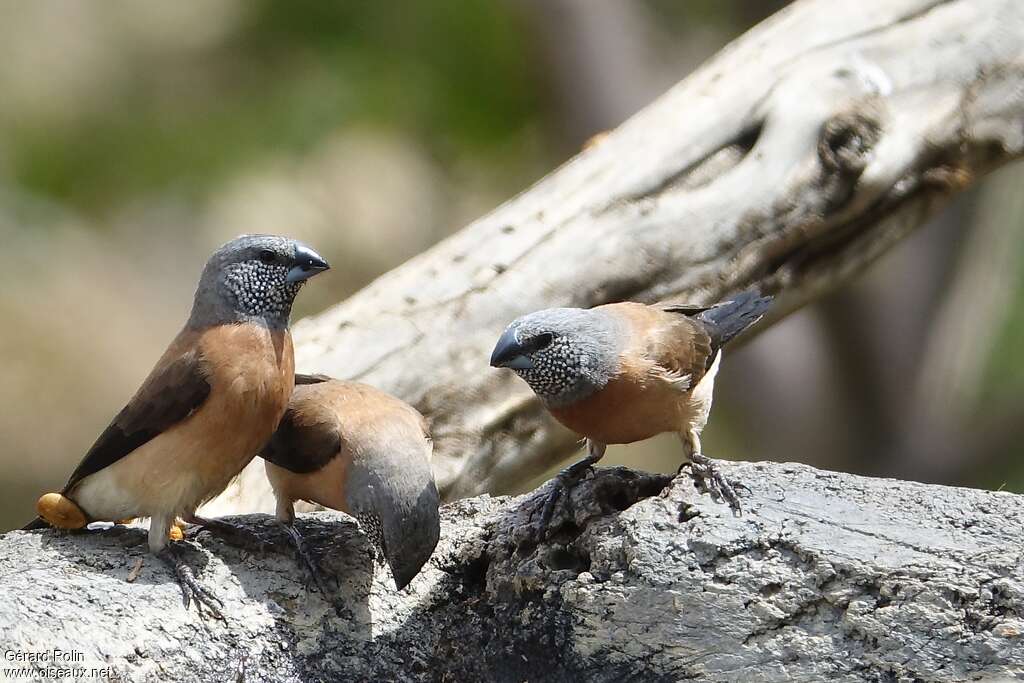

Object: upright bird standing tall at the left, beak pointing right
[27,234,330,615]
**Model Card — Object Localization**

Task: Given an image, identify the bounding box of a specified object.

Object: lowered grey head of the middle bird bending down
[345,442,440,591]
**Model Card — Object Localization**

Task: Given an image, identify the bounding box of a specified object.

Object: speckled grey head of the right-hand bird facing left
[490,308,625,408]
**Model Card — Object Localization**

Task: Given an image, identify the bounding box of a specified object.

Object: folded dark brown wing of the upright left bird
[65,333,210,492]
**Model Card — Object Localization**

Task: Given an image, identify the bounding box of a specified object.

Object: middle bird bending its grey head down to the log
[260,375,440,594]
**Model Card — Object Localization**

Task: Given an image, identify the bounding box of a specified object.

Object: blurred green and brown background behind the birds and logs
[0,0,1024,529]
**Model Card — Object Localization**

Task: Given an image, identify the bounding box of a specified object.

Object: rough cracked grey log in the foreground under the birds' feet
[0,464,1024,683]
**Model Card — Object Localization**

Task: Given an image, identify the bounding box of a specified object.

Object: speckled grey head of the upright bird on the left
[189,234,330,328]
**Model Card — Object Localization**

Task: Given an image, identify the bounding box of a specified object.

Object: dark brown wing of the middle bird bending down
[260,385,341,474]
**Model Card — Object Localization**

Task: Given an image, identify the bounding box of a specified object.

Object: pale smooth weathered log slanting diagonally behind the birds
[203,0,1024,512]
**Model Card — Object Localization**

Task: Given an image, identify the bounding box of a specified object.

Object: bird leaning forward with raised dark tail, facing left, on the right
[490,290,772,533]
